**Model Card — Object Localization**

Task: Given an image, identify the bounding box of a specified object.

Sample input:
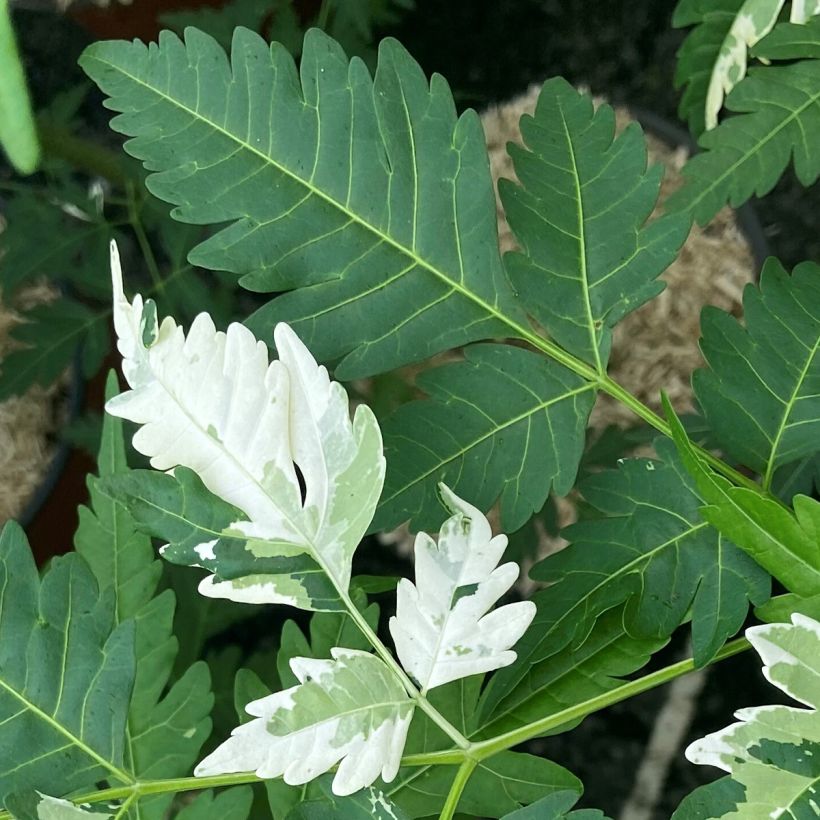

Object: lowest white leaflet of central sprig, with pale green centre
[194,648,413,795]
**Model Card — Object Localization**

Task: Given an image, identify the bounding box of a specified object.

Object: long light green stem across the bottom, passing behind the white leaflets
[0,636,750,820]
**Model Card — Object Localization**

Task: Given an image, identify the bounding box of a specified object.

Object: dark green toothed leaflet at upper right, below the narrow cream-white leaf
[666,60,820,224]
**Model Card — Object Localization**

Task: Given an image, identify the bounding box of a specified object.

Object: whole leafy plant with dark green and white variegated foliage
[0,4,820,820]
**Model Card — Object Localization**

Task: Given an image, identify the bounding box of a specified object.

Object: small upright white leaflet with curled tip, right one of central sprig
[390,484,535,692]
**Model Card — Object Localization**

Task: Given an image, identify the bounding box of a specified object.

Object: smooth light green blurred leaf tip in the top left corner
[0,0,40,174]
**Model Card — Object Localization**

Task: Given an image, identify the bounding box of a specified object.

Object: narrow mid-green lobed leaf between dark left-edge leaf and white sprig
[74,373,214,820]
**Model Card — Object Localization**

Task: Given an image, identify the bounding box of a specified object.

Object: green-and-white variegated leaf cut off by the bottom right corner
[686,613,820,820]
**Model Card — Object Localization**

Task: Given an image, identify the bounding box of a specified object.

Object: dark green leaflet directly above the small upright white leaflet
[371,345,595,531]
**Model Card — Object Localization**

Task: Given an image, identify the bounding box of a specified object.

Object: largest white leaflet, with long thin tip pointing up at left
[106,240,384,605]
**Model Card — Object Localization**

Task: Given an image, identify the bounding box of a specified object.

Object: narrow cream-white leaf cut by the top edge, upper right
[705,0,785,130]
